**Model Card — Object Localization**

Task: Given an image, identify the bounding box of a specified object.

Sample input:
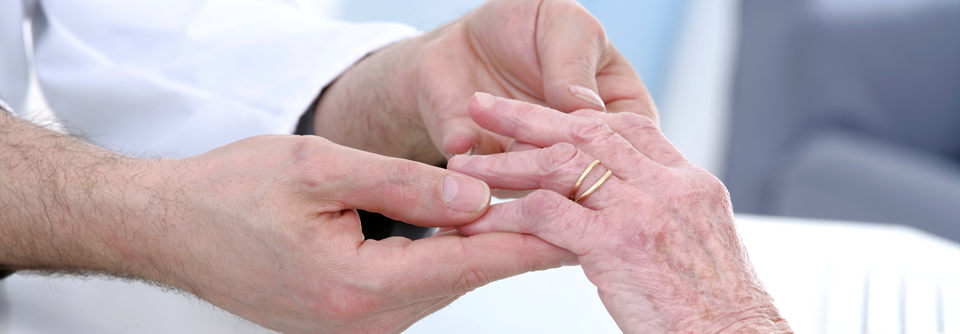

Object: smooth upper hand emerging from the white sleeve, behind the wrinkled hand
[314,0,657,164]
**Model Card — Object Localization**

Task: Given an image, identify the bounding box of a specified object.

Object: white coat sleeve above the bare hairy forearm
[34,0,418,157]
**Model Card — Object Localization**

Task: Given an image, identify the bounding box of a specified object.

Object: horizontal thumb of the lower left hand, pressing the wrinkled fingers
[332,148,490,227]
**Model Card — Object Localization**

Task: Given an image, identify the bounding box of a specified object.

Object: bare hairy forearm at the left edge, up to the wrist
[0,111,176,278]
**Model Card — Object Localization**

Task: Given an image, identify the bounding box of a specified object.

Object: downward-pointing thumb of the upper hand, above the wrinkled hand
[536,0,608,112]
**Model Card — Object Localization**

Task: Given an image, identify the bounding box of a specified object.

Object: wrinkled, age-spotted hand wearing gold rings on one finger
[447,94,790,333]
